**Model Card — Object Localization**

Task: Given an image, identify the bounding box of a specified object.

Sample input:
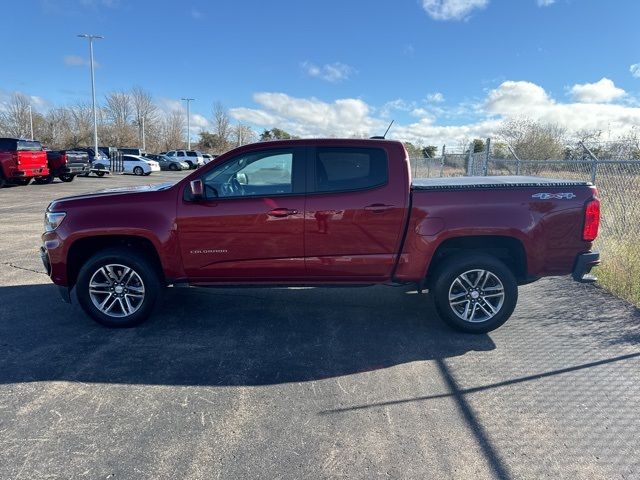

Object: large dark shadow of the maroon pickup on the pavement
[0,285,495,385]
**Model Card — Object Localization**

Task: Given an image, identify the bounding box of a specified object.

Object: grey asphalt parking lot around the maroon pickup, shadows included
[0,173,640,479]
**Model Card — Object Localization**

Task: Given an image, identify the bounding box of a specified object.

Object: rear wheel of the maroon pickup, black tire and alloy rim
[431,253,518,333]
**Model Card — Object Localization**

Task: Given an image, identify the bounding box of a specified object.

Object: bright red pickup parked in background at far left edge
[0,138,49,187]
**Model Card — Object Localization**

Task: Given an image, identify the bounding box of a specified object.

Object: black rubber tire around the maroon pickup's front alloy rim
[75,248,162,328]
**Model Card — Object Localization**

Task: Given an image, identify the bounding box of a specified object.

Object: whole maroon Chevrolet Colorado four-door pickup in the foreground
[41,139,600,332]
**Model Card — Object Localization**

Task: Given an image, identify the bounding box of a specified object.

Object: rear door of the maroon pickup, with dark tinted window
[304,146,409,281]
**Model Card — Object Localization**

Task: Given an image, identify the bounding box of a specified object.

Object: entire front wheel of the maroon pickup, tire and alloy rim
[76,248,161,328]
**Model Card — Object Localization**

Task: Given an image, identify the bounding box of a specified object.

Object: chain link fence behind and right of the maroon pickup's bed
[411,140,640,306]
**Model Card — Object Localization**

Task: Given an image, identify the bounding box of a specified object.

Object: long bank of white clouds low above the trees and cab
[230,81,640,145]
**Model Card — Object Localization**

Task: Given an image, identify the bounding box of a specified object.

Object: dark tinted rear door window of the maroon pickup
[314,147,388,192]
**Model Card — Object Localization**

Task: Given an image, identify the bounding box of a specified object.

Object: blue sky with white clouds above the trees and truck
[0,0,640,142]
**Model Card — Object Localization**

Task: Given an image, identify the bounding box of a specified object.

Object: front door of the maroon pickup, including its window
[177,148,305,283]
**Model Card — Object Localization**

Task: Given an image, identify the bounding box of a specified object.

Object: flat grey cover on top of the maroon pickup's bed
[411,175,591,190]
